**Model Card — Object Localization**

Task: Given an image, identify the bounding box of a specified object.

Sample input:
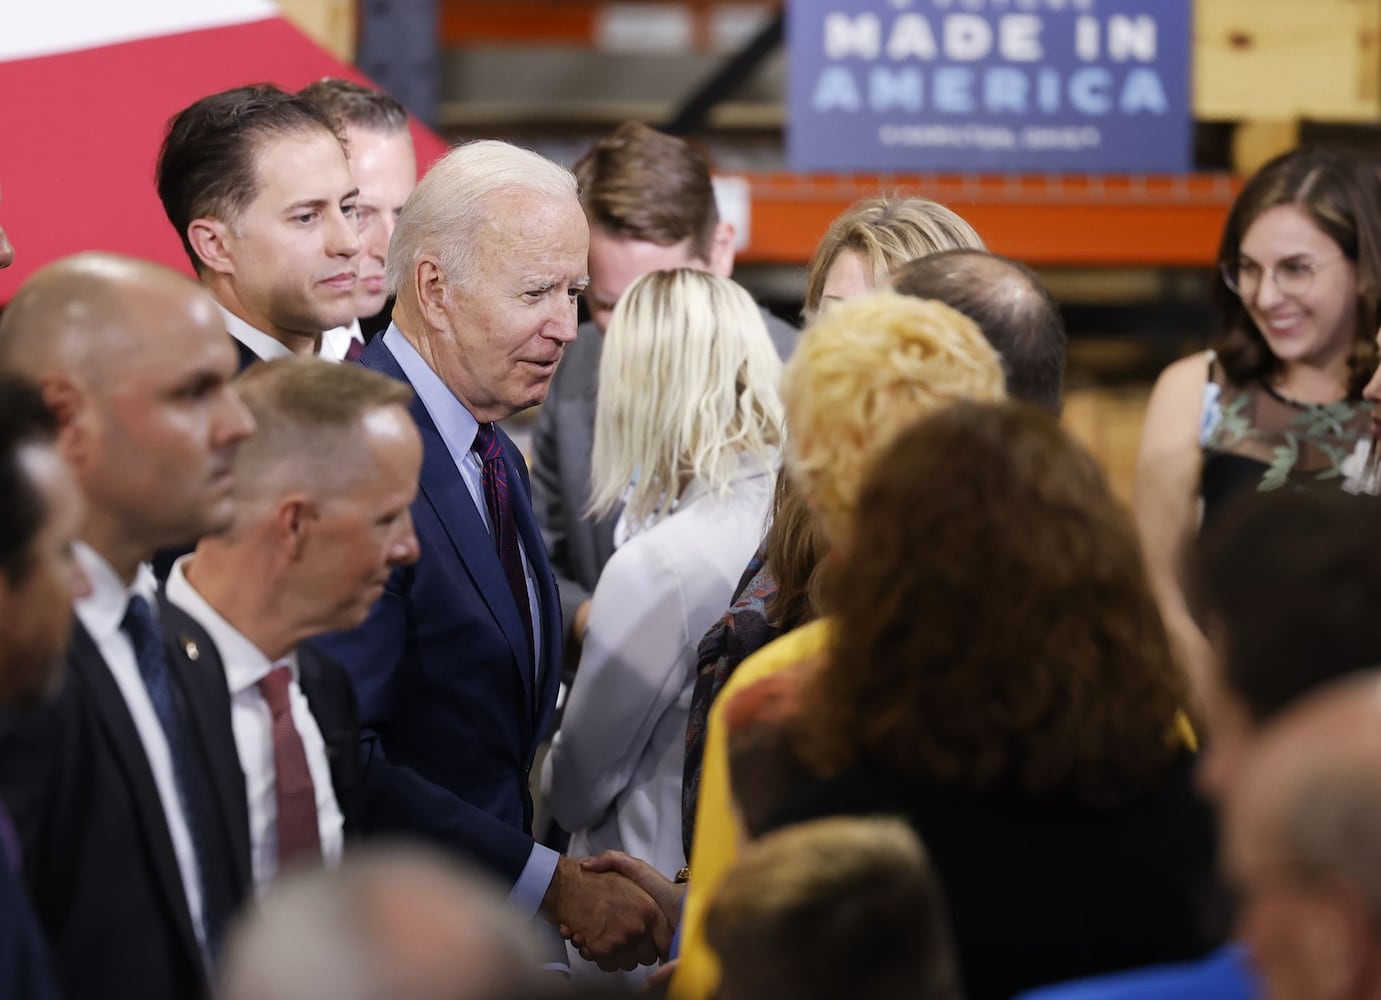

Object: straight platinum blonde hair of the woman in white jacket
[590,268,782,522]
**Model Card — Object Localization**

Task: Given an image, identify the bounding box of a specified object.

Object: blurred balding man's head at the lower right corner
[1224,671,1381,1000]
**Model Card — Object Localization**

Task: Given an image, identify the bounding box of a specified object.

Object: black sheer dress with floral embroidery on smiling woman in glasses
[1199,356,1381,525]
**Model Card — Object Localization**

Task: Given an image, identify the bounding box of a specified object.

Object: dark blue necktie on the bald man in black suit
[120,594,229,960]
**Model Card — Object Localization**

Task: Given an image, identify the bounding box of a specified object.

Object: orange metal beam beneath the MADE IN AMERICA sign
[739,174,1240,267]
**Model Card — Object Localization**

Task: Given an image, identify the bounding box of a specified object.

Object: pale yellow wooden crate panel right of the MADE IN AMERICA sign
[1195,0,1381,122]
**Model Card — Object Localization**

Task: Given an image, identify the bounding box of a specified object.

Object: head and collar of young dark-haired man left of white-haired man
[157,84,360,367]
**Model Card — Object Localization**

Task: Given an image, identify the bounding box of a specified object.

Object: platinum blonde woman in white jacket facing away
[543,269,782,955]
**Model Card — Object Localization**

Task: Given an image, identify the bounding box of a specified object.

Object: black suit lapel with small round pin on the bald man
[159,591,254,895]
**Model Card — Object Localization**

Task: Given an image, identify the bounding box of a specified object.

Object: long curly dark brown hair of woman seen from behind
[798,402,1186,805]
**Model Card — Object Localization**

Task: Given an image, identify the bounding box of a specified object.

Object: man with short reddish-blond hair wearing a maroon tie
[166,358,423,891]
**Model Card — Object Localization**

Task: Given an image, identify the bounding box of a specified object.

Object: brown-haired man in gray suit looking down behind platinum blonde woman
[532,122,797,664]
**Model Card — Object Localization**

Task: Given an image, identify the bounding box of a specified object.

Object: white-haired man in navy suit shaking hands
[323,142,670,968]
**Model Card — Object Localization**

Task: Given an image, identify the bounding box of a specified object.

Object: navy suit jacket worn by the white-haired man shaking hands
[318,337,561,883]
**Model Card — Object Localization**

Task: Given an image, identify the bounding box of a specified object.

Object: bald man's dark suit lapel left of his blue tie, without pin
[68,622,202,965]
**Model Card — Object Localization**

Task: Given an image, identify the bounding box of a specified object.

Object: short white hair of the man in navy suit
[384,140,580,294]
